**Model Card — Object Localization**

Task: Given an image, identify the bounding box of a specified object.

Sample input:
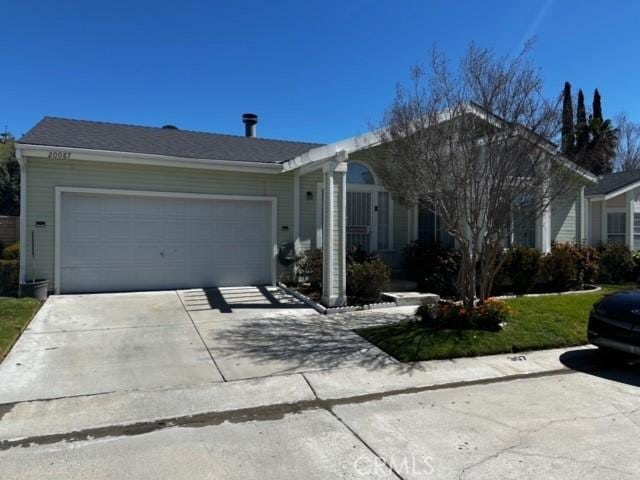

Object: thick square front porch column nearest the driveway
[322,151,347,307]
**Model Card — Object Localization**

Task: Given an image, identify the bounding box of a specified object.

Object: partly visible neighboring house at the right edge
[585,170,640,250]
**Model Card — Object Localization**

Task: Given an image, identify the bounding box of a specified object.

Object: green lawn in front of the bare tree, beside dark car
[357,285,635,362]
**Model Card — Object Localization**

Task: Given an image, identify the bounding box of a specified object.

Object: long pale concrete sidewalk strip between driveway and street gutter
[0,347,598,448]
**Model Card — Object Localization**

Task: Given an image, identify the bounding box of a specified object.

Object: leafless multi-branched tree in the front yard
[379,44,578,308]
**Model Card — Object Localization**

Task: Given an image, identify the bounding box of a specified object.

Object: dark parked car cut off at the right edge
[588,290,640,355]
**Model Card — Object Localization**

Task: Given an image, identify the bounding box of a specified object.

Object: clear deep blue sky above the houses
[5,0,640,142]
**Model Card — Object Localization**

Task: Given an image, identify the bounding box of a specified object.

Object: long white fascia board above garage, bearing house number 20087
[16,143,284,173]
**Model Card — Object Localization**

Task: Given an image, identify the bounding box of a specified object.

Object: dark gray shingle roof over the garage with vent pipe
[19,117,320,163]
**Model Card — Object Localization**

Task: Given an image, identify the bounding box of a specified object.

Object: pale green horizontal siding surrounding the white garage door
[23,158,293,288]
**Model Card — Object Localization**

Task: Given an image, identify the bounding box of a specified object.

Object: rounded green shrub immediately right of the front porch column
[347,258,391,304]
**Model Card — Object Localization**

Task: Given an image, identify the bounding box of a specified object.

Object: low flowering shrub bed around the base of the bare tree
[416,298,512,330]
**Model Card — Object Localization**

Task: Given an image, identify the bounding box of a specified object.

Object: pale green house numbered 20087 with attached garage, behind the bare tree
[16,114,594,305]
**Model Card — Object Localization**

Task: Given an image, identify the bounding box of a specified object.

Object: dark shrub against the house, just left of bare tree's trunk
[403,243,460,297]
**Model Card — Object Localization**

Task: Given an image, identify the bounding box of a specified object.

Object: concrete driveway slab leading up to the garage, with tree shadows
[0,287,393,404]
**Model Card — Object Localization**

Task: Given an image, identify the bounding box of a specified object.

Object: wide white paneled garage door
[60,193,273,293]
